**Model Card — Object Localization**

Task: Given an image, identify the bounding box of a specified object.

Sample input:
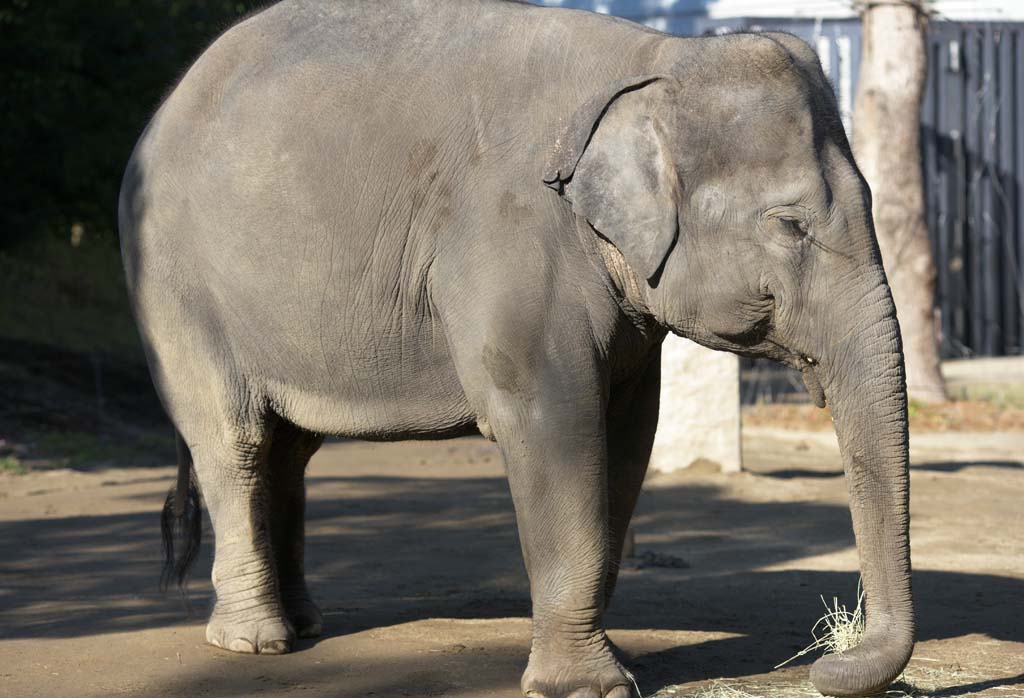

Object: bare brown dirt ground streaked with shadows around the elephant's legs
[0,429,1024,698]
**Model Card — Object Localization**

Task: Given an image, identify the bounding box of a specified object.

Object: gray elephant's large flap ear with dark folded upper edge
[544,76,679,280]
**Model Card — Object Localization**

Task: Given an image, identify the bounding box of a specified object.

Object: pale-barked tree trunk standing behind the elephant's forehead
[853,0,946,402]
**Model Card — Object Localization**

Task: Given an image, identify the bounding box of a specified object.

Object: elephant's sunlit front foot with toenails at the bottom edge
[522,638,639,698]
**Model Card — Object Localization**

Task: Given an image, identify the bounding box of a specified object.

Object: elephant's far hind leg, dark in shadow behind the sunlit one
[269,422,324,638]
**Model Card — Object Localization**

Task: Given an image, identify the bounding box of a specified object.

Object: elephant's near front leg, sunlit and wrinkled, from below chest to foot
[492,397,633,698]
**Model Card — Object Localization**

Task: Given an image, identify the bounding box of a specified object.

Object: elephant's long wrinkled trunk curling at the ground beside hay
[811,269,914,696]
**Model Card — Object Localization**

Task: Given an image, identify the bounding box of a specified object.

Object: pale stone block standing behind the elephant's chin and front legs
[650,335,742,473]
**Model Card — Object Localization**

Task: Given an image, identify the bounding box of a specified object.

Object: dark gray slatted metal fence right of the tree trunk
[922,23,1024,356]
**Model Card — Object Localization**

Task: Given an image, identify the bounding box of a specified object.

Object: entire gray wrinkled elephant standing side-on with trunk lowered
[120,0,913,698]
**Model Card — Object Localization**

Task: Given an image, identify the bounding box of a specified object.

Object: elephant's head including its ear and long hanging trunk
[545,35,913,696]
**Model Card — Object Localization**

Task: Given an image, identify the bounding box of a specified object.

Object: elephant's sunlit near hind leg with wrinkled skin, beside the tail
[186,417,295,654]
